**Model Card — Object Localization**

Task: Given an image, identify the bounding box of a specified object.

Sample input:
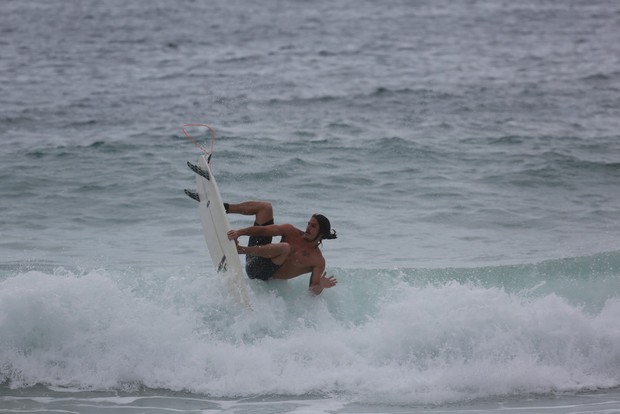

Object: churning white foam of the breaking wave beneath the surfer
[0,270,620,404]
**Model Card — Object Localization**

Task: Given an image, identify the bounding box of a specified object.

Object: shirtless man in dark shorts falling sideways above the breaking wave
[226,201,337,295]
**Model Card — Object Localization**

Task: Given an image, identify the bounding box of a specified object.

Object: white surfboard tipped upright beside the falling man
[193,155,252,309]
